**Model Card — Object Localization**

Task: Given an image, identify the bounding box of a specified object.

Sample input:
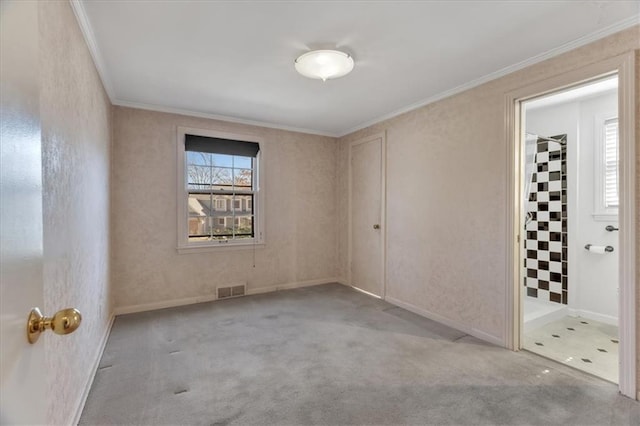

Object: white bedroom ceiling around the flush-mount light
[72,0,640,136]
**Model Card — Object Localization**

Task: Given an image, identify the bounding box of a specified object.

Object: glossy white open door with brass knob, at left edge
[0,1,46,424]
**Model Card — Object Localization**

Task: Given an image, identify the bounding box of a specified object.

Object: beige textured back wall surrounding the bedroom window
[112,107,339,308]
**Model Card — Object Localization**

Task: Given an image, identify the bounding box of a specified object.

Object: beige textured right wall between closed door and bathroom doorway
[337,27,640,348]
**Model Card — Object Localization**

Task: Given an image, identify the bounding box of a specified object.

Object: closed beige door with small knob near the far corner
[349,135,384,297]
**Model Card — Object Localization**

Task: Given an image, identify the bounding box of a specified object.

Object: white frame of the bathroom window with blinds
[593,111,620,222]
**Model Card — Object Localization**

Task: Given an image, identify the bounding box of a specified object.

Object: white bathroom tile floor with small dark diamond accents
[524,316,619,383]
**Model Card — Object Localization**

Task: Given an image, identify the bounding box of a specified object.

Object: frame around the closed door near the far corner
[347,131,387,300]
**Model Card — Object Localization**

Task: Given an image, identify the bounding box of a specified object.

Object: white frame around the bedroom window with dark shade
[176,127,266,254]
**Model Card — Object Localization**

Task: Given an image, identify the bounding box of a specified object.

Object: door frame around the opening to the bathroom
[504,52,640,399]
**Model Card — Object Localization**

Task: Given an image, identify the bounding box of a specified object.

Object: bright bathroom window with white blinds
[593,115,620,221]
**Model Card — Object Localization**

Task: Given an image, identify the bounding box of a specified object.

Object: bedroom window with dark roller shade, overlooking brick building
[178,128,263,251]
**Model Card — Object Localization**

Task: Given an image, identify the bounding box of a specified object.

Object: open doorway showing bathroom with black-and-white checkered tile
[520,75,620,383]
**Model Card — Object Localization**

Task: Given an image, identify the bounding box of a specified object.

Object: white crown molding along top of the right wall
[338,14,640,137]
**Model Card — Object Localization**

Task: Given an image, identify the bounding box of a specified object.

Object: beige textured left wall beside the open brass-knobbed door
[38,1,111,425]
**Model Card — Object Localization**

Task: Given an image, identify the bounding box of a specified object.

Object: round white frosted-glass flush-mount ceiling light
[295,50,354,81]
